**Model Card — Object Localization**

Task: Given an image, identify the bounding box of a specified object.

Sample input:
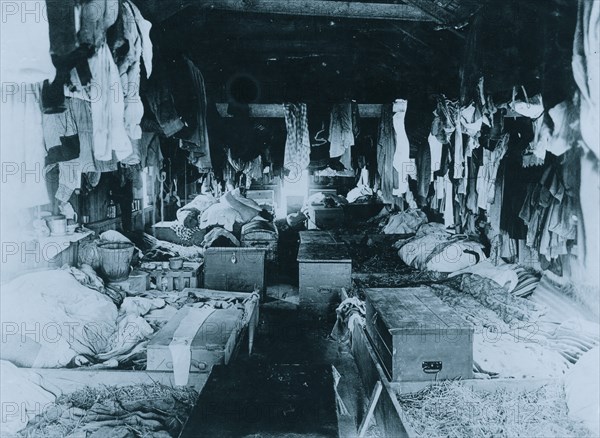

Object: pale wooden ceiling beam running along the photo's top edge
[197,0,433,21]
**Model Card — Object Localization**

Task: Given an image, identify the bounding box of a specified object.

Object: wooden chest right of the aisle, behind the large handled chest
[297,243,352,315]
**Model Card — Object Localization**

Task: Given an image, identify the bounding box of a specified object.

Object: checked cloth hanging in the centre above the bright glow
[283,103,310,176]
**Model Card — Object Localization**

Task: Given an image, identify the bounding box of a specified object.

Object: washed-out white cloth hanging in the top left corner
[0,0,56,84]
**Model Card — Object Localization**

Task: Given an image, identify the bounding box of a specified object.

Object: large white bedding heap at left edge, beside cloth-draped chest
[0,268,164,368]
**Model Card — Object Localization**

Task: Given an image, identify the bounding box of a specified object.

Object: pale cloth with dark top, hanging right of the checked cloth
[329,103,355,170]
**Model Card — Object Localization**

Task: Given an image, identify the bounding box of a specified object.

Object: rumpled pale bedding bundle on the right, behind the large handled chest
[396,223,487,273]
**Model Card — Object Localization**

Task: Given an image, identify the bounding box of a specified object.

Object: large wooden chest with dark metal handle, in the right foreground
[365,287,473,381]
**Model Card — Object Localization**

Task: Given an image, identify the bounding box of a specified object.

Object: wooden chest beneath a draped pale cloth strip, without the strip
[146,307,243,372]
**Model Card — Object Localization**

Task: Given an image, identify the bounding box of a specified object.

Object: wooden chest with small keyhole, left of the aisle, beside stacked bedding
[204,248,266,295]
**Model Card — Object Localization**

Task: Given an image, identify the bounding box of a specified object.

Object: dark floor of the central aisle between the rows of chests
[218,224,381,437]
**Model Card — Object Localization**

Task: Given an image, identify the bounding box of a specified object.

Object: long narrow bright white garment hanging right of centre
[393,99,416,196]
